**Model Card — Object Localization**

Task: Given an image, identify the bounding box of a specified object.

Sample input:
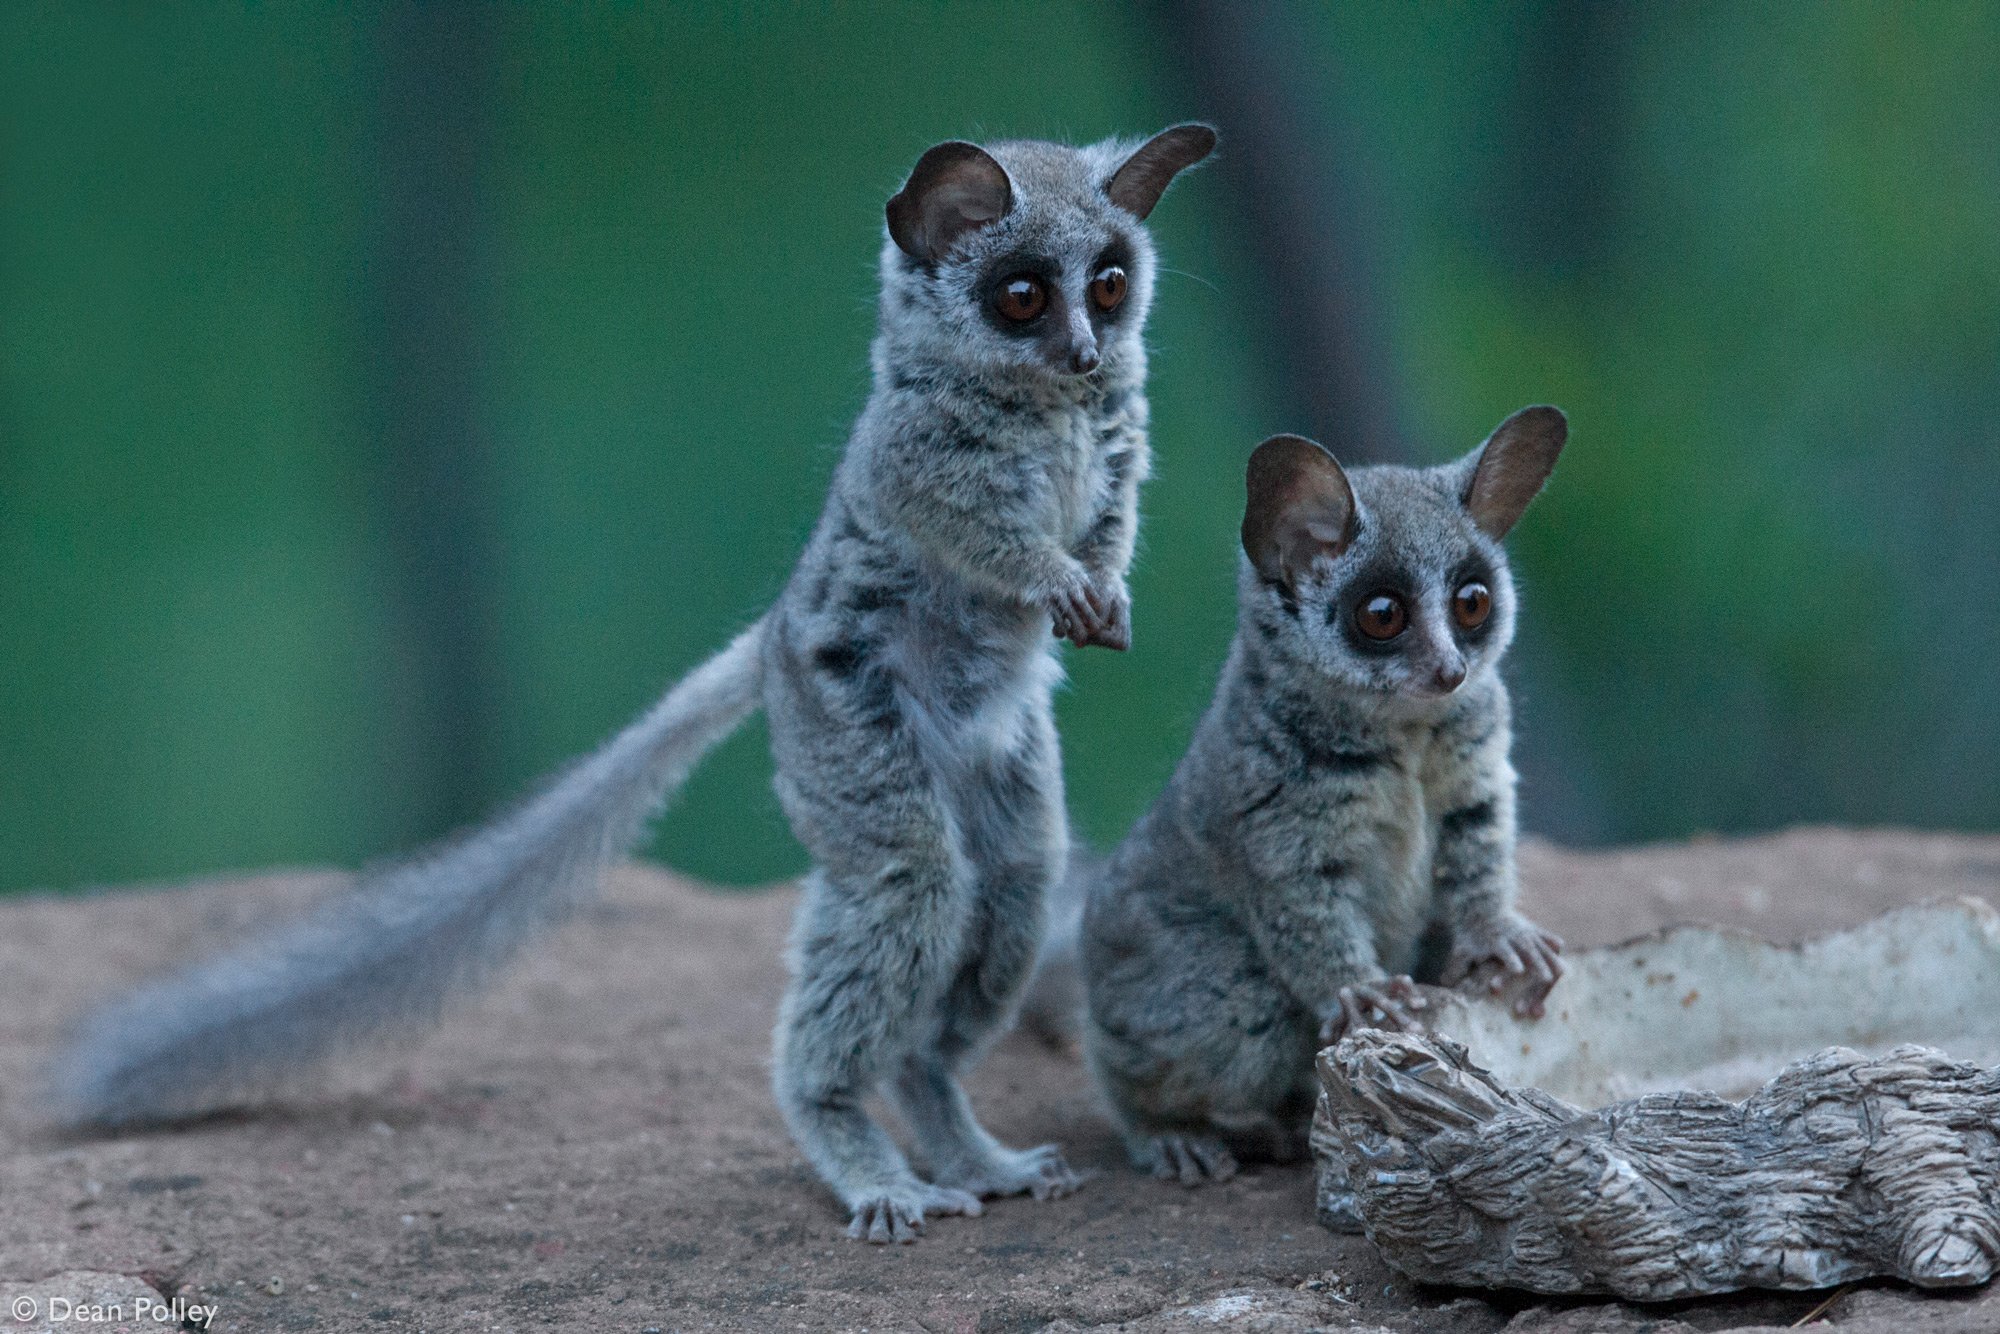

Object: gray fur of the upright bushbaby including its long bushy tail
[54,130,1206,1240]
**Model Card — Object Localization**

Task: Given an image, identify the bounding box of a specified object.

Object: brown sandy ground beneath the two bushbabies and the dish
[0,830,2000,1334]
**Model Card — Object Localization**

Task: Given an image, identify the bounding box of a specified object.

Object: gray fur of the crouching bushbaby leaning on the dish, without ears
[1082,414,1560,1184]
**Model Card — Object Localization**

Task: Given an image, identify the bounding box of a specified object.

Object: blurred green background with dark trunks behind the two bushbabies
[0,0,2000,890]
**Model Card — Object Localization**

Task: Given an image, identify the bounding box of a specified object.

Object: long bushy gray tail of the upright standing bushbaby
[48,622,762,1126]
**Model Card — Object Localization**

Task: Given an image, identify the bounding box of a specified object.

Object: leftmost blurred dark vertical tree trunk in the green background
[360,0,500,836]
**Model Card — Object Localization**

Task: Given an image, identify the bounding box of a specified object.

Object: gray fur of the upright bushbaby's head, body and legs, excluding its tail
[764,144,1184,1240]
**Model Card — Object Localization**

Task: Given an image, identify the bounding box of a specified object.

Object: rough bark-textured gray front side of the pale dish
[1314,1030,2000,1300]
